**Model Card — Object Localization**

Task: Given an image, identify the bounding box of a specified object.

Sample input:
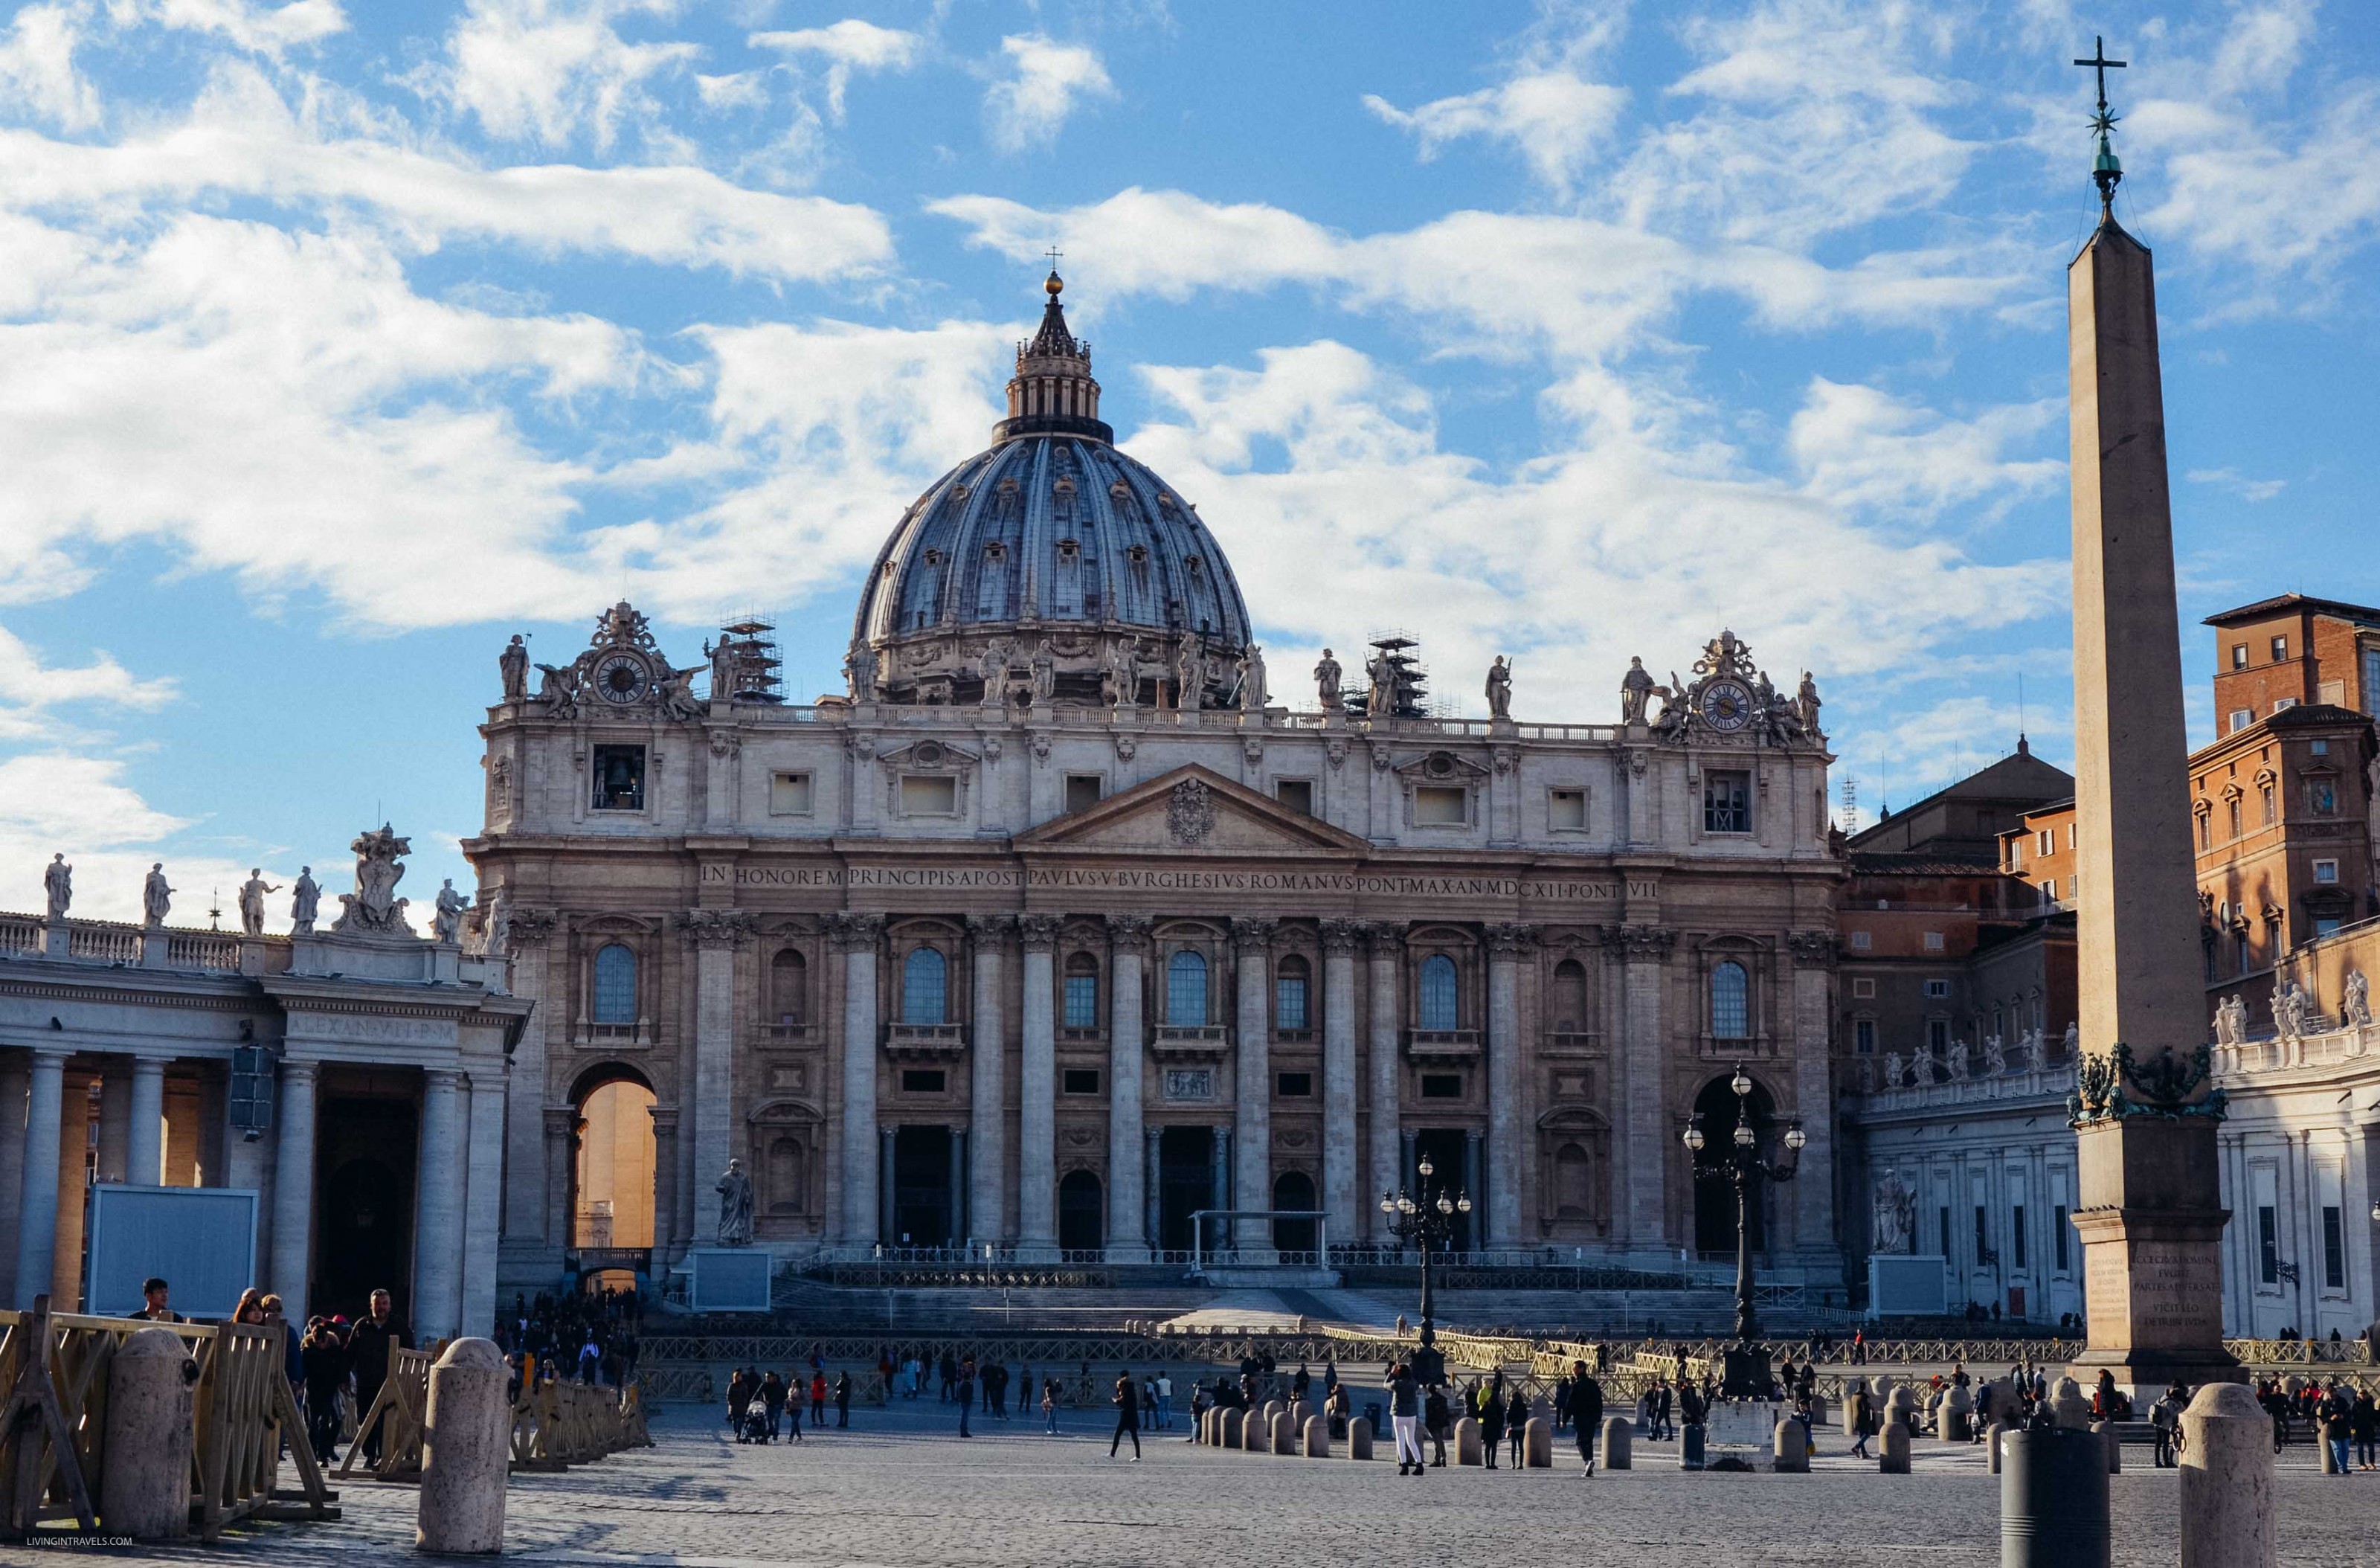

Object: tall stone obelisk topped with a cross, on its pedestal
[2066,50,2239,1399]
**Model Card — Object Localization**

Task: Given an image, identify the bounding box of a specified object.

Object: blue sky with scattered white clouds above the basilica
[0,0,2380,925]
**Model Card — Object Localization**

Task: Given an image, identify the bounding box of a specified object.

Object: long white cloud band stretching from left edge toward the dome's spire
[0,67,892,278]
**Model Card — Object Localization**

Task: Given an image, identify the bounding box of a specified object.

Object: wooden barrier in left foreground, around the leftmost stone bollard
[0,1297,338,1542]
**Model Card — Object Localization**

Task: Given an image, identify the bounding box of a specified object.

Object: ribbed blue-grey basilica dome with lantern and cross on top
[852,274,1250,702]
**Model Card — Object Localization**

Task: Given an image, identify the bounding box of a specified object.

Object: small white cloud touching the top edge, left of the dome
[414,0,700,150]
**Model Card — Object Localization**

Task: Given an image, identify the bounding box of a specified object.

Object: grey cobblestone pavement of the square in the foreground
[32,1401,2380,1568]
